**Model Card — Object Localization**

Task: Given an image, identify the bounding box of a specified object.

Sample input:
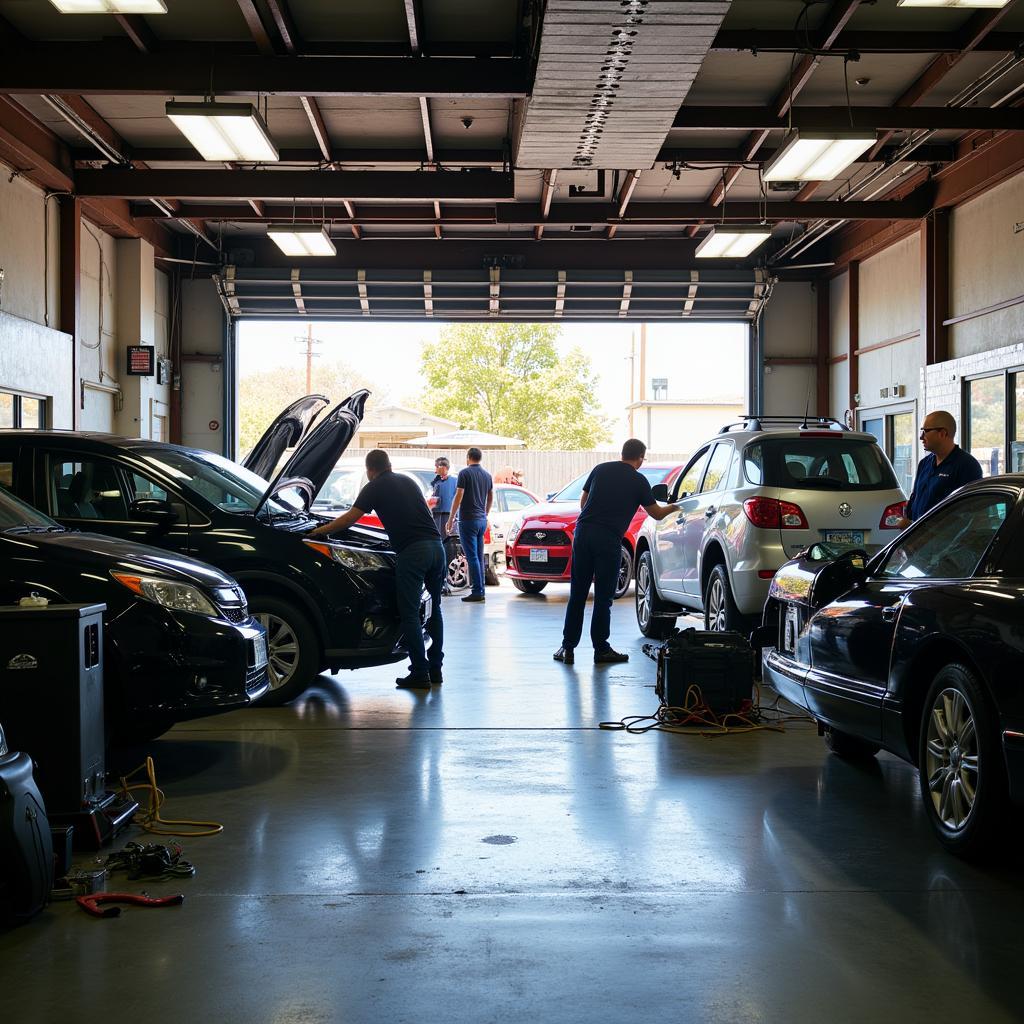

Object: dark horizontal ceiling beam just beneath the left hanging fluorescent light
[75,168,515,202]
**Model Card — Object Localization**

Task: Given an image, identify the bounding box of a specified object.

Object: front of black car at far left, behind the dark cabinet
[0,483,268,741]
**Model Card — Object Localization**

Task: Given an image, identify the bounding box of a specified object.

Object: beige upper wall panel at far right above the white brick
[949,174,1024,358]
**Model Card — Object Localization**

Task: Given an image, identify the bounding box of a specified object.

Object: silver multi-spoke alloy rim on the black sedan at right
[925,688,978,831]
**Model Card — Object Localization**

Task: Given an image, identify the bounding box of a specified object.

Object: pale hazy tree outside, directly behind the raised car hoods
[239,362,387,455]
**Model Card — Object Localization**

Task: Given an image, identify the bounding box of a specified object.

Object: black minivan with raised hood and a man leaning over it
[0,391,429,705]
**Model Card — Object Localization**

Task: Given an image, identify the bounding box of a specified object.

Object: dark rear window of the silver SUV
[743,436,899,490]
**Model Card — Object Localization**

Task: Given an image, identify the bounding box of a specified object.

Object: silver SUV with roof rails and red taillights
[634,416,906,638]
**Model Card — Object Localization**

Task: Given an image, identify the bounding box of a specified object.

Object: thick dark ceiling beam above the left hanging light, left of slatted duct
[0,55,531,98]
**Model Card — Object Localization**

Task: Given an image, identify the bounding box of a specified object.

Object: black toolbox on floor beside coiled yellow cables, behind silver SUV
[643,629,754,715]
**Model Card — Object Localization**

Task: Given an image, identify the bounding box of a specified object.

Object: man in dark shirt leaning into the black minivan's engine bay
[308,449,444,690]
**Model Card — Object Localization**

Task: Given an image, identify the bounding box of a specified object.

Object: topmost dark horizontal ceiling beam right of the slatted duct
[711,28,1021,53]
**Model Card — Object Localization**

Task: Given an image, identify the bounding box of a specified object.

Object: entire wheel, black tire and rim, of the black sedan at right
[918,664,1008,859]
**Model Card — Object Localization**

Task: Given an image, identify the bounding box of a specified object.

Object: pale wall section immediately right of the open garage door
[761,282,818,416]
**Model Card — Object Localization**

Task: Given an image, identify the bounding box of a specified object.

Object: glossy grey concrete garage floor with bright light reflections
[0,581,1024,1024]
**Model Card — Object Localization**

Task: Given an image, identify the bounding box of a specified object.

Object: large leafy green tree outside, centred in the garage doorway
[421,324,609,450]
